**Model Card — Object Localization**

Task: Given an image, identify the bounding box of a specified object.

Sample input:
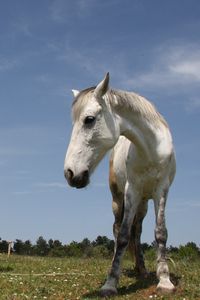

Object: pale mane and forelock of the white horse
[72,87,168,127]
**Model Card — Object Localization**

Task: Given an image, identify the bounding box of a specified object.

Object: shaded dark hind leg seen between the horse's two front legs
[129,200,148,277]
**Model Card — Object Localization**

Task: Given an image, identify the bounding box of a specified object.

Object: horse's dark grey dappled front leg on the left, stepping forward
[101,183,139,297]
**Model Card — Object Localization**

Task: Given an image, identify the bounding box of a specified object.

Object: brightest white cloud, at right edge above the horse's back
[126,44,200,88]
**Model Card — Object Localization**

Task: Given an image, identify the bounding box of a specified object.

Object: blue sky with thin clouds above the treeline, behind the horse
[0,0,200,245]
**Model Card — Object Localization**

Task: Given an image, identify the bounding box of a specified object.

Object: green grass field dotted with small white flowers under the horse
[0,254,200,300]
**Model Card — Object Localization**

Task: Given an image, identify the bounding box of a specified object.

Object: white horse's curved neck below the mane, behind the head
[108,91,172,161]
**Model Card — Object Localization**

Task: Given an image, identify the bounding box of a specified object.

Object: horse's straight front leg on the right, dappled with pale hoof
[154,189,175,293]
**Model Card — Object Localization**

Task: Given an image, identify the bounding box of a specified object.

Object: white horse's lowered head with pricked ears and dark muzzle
[64,74,119,188]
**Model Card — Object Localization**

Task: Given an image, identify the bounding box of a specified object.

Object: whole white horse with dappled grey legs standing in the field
[64,73,176,296]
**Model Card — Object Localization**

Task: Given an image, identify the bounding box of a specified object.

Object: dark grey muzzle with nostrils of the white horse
[64,169,89,189]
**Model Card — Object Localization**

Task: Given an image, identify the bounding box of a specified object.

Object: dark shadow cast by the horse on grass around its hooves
[81,269,180,300]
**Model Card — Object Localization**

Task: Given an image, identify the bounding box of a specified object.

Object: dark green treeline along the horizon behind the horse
[0,236,200,259]
